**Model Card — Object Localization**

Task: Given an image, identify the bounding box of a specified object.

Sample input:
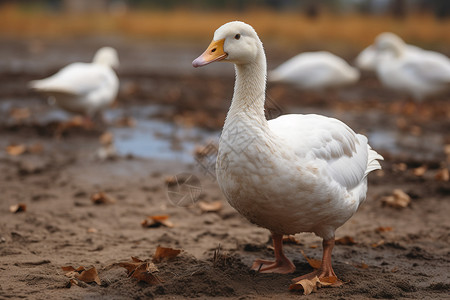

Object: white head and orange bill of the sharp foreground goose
[192,21,264,68]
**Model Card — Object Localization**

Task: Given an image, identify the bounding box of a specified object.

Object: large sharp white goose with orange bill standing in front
[192,21,383,280]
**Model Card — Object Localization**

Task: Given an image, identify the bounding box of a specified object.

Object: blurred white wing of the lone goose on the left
[30,63,110,96]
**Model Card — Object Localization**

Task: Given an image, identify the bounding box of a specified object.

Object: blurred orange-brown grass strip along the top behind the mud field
[0,0,450,51]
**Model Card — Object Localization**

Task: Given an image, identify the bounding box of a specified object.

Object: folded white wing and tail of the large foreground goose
[269,114,382,190]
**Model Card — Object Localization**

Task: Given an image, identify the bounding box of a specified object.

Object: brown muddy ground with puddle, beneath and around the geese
[0,38,450,299]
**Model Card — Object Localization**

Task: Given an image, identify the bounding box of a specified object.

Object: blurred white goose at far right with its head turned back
[375,33,450,101]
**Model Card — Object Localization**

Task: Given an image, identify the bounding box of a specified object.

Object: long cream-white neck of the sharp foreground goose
[225,51,267,126]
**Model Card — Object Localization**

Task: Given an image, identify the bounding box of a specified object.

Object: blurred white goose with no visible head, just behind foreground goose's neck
[268,51,360,91]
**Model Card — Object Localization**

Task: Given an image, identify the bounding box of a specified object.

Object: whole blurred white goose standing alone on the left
[29,47,119,117]
